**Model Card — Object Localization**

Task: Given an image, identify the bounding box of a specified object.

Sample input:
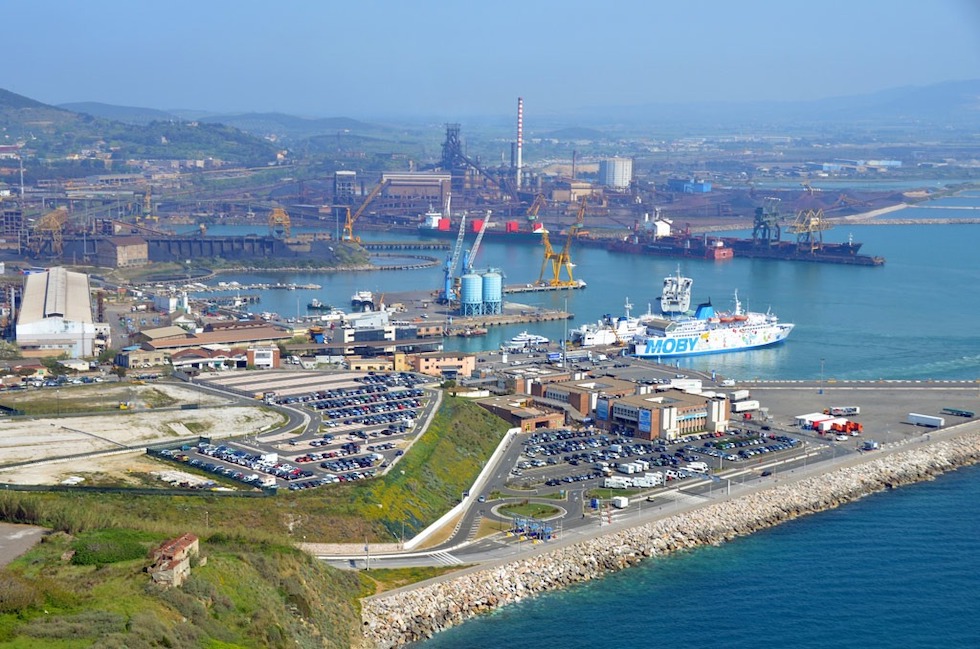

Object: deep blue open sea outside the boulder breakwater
[423,466,980,649]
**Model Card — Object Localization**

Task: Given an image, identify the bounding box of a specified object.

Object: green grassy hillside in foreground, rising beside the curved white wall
[0,398,506,649]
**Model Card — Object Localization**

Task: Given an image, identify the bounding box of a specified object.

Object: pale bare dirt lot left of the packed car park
[0,383,283,484]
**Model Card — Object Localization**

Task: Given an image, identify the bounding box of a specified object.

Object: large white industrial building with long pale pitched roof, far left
[16,267,108,358]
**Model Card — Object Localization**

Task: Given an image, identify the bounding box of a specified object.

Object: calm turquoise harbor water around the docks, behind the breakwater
[221,205,980,380]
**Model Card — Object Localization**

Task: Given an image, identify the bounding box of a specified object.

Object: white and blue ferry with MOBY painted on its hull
[630,278,794,358]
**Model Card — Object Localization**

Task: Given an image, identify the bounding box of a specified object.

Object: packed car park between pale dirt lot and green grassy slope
[157,372,431,491]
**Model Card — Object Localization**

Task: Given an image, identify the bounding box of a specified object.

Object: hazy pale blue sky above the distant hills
[7,0,980,118]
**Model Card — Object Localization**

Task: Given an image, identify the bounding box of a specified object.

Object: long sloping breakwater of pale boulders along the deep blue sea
[362,432,980,647]
